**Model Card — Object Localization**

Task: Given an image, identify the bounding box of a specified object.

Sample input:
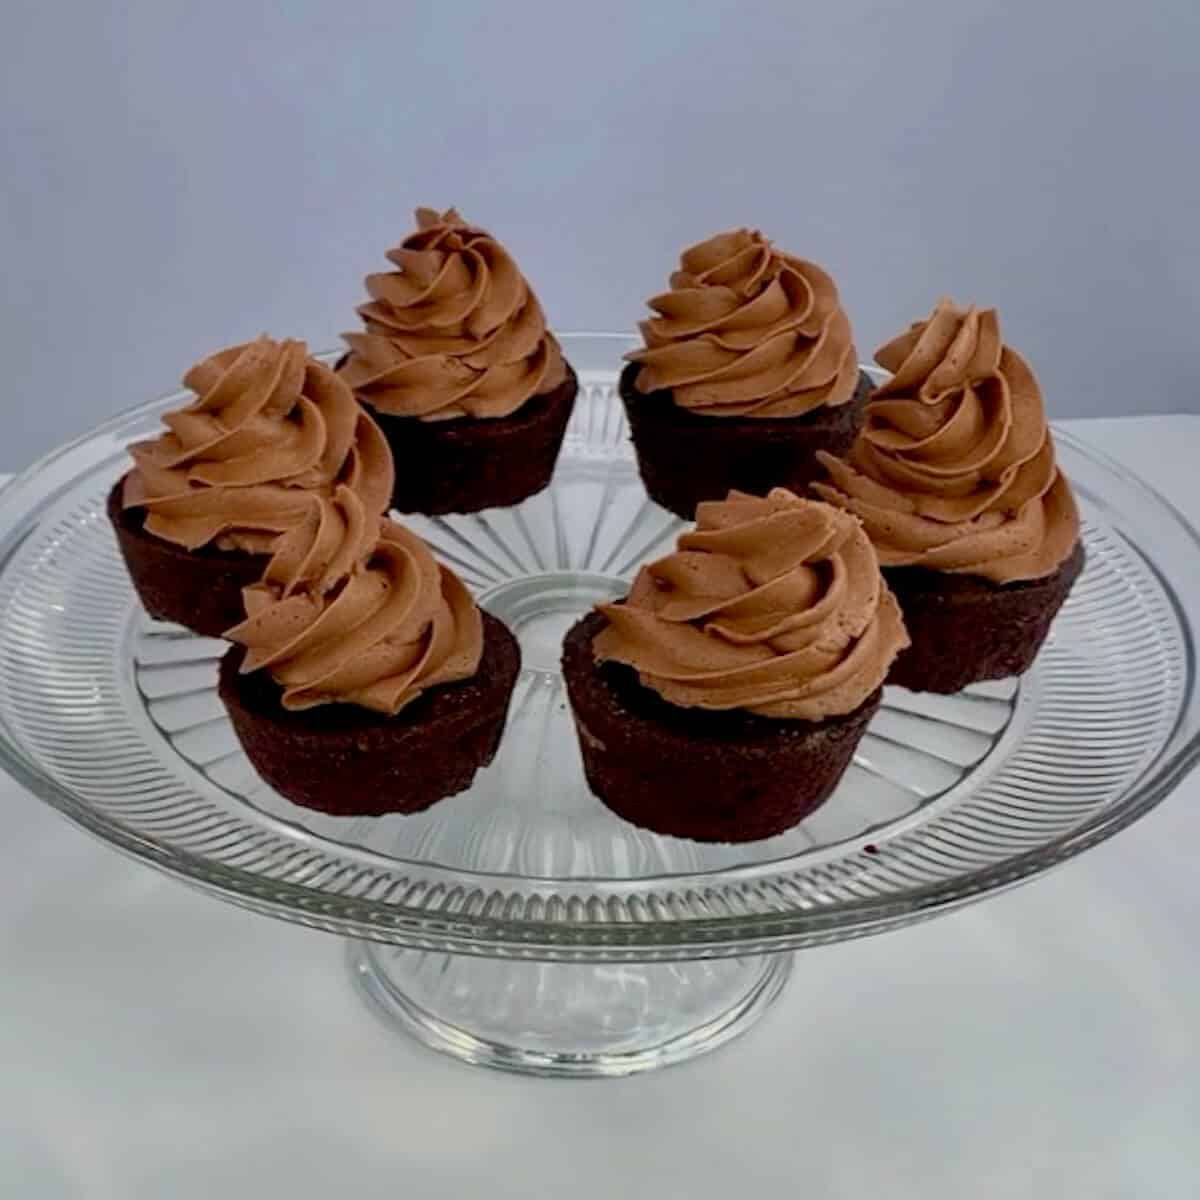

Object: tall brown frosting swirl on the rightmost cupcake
[814,300,1079,583]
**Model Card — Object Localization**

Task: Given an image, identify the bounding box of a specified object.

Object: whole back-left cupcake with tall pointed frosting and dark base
[338,209,576,515]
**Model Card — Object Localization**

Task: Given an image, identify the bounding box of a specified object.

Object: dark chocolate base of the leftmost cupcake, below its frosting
[107,479,270,637]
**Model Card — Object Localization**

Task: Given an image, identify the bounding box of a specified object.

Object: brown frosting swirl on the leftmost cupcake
[122,336,392,553]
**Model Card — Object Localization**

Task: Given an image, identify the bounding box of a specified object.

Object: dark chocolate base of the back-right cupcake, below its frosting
[620,362,875,521]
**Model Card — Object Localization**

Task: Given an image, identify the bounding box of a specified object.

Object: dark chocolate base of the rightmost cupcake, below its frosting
[883,542,1085,694]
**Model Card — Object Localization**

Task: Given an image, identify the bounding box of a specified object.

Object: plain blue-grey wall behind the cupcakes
[0,0,1200,468]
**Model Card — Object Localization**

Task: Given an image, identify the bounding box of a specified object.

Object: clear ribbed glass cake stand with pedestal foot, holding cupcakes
[0,334,1200,1075]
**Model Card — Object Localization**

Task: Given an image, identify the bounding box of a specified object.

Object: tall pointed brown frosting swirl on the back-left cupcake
[341,209,566,421]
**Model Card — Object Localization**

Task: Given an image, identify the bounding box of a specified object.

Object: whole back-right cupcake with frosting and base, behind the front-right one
[620,229,871,520]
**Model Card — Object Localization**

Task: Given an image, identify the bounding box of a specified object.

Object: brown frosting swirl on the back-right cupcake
[628,229,858,418]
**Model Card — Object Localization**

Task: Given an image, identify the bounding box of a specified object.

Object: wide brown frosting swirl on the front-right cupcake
[593,488,908,721]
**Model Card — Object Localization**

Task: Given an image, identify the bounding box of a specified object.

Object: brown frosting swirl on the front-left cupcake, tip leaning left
[226,516,484,715]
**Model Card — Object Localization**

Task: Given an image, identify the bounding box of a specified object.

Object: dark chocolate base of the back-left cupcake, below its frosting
[348,367,578,516]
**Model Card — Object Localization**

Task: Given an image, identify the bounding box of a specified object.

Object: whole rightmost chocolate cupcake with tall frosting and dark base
[814,300,1084,692]
